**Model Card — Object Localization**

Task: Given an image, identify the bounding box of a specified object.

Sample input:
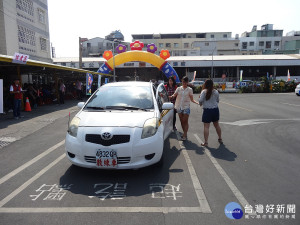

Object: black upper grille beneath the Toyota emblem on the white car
[85,134,130,146]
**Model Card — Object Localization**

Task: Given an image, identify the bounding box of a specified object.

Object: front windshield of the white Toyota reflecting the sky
[85,86,154,110]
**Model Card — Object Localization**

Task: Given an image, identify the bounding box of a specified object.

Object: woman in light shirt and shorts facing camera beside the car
[170,76,199,141]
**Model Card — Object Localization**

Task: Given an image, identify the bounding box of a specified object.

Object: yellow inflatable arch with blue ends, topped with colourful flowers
[97,41,180,82]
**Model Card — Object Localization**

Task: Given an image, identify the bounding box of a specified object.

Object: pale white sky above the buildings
[48,0,300,57]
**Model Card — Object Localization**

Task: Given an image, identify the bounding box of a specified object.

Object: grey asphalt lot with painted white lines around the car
[0,93,300,225]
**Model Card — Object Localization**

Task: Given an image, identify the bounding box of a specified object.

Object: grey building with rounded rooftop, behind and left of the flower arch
[82,30,130,57]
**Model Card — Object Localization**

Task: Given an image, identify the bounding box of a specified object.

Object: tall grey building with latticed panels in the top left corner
[0,0,52,62]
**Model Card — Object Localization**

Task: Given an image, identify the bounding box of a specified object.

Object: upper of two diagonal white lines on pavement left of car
[0,140,65,184]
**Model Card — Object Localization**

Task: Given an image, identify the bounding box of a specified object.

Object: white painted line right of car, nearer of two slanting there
[176,131,212,213]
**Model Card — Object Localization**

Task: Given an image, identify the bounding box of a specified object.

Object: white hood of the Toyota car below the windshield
[77,111,155,127]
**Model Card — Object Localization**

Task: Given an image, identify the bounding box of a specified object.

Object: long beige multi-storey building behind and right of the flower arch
[132,32,239,56]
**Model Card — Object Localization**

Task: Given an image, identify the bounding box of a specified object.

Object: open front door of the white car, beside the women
[156,84,174,139]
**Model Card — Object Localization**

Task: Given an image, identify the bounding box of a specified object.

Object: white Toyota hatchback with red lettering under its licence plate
[65,82,173,169]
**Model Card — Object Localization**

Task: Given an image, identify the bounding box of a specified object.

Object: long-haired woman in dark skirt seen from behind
[199,79,223,146]
